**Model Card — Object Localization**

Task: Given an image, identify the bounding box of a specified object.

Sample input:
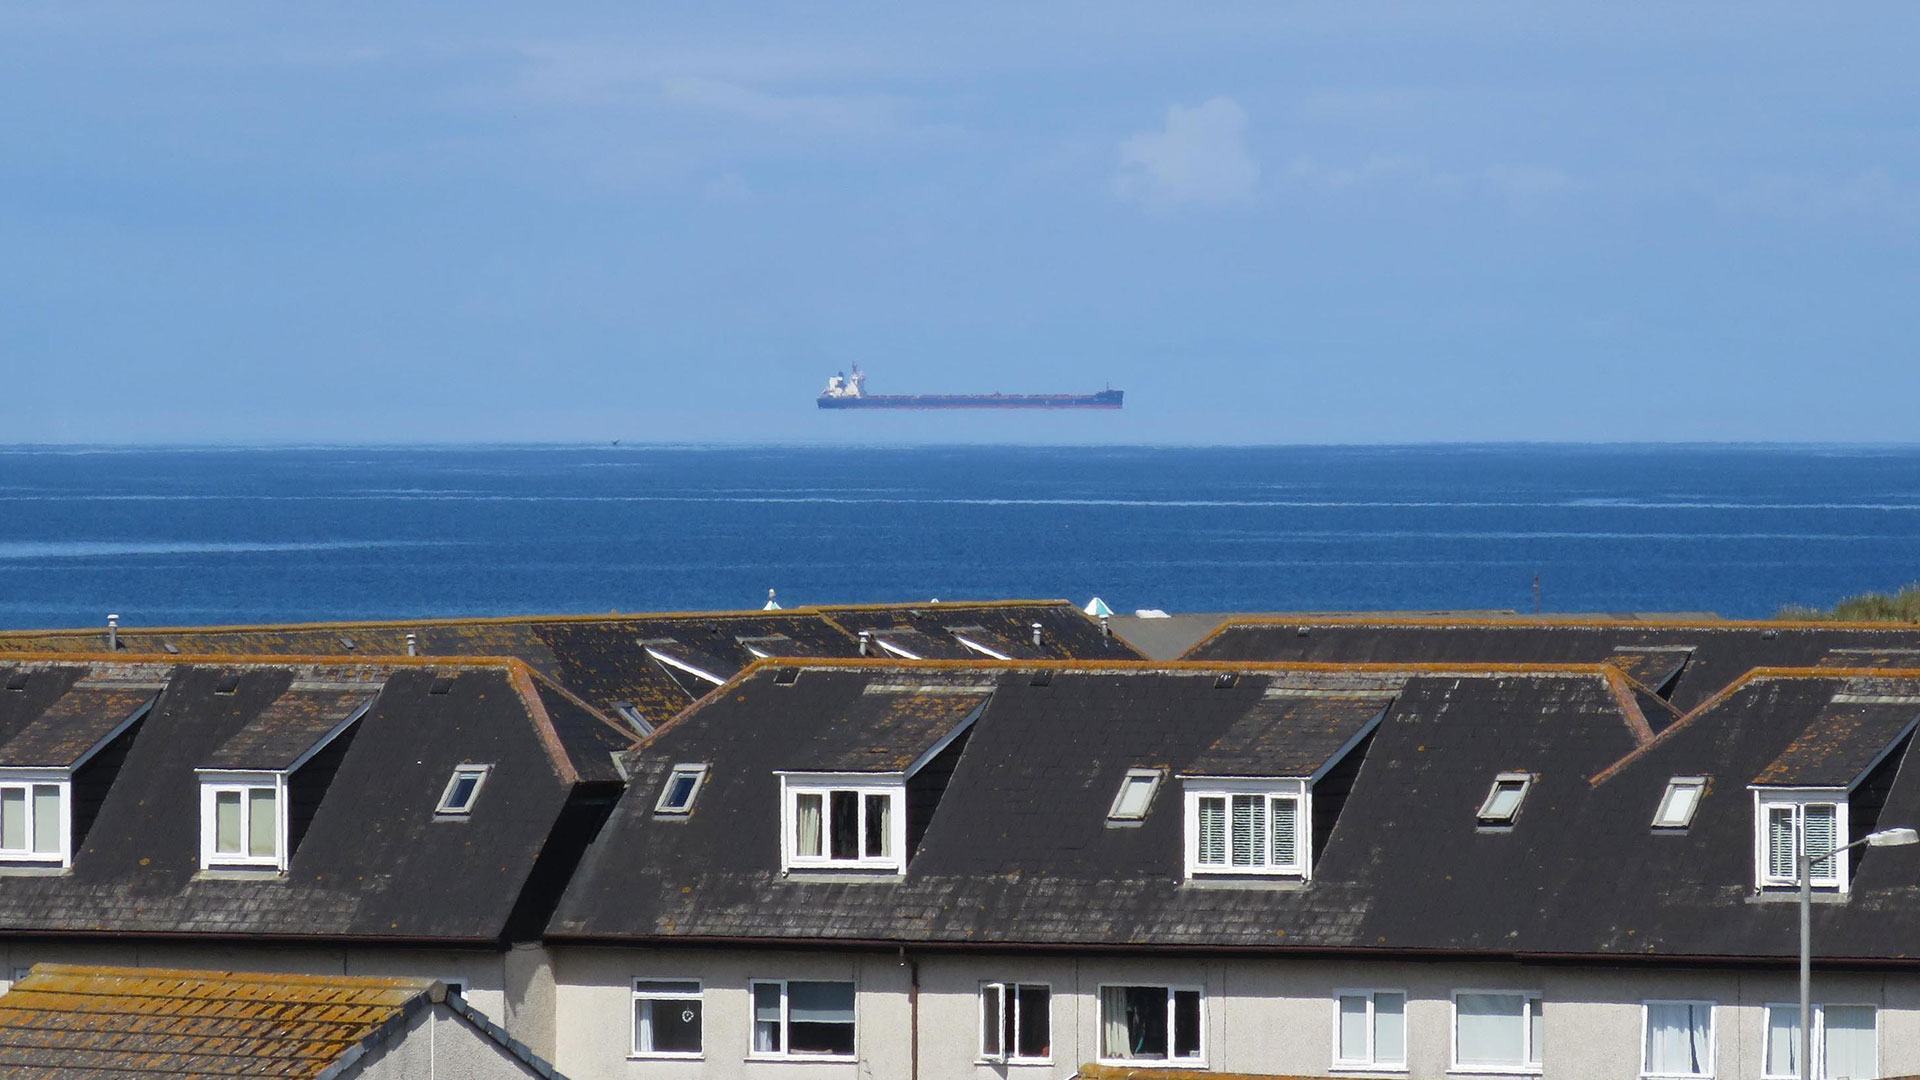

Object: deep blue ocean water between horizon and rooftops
[0,446,1920,626]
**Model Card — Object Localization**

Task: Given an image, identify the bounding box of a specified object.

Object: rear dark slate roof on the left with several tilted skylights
[0,600,1139,724]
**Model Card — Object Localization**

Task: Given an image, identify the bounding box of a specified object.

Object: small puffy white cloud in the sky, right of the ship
[1114,98,1260,206]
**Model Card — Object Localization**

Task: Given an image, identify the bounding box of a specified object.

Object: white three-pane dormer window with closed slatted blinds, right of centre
[1187,778,1311,878]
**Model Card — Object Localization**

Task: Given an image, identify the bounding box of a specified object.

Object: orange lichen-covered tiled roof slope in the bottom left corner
[0,965,436,1076]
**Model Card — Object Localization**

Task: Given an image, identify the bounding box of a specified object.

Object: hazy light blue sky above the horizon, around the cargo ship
[0,0,1920,442]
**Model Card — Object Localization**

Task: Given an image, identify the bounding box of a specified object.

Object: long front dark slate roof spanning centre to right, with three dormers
[549,663,1920,963]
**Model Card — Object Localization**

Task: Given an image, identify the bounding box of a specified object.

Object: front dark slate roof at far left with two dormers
[0,657,632,944]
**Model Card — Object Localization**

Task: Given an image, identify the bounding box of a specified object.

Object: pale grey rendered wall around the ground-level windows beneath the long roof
[555,949,1920,1080]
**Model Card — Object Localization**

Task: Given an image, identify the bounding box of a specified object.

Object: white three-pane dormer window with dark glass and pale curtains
[780,774,906,872]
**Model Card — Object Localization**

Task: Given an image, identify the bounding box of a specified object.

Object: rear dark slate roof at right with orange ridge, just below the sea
[1185,615,1920,711]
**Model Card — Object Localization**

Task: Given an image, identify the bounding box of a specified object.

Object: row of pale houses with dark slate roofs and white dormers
[0,603,1920,1080]
